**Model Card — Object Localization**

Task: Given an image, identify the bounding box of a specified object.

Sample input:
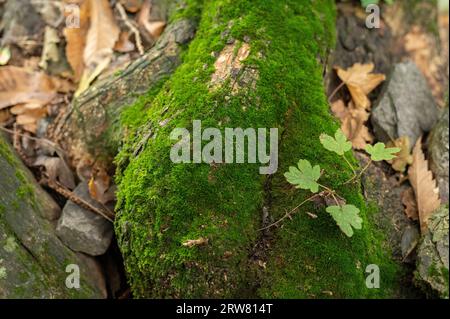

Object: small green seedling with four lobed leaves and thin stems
[274,129,400,237]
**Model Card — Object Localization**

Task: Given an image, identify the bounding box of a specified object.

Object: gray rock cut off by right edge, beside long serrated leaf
[428,107,449,204]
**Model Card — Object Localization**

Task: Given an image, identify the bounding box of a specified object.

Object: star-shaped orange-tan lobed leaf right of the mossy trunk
[336,63,386,110]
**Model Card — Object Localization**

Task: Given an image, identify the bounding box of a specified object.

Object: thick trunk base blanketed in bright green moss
[115,0,395,298]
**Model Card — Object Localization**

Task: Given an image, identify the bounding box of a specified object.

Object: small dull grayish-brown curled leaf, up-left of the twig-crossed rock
[34,155,75,189]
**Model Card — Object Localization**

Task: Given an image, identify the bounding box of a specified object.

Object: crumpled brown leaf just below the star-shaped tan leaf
[331,100,373,150]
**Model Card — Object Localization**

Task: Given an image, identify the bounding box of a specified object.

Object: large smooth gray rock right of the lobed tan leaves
[371,62,439,147]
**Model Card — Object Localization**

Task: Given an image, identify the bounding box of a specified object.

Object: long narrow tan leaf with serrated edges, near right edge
[408,138,441,233]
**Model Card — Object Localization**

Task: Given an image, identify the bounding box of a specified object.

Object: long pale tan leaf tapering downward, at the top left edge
[75,0,120,96]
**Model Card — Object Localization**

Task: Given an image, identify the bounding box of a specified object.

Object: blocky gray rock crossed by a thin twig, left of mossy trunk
[56,182,113,256]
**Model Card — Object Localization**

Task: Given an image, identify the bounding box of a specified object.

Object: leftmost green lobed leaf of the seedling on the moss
[284,160,320,193]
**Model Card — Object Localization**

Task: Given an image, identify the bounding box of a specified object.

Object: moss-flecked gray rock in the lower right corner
[415,206,449,298]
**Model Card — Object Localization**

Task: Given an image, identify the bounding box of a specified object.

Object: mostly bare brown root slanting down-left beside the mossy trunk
[52,13,196,163]
